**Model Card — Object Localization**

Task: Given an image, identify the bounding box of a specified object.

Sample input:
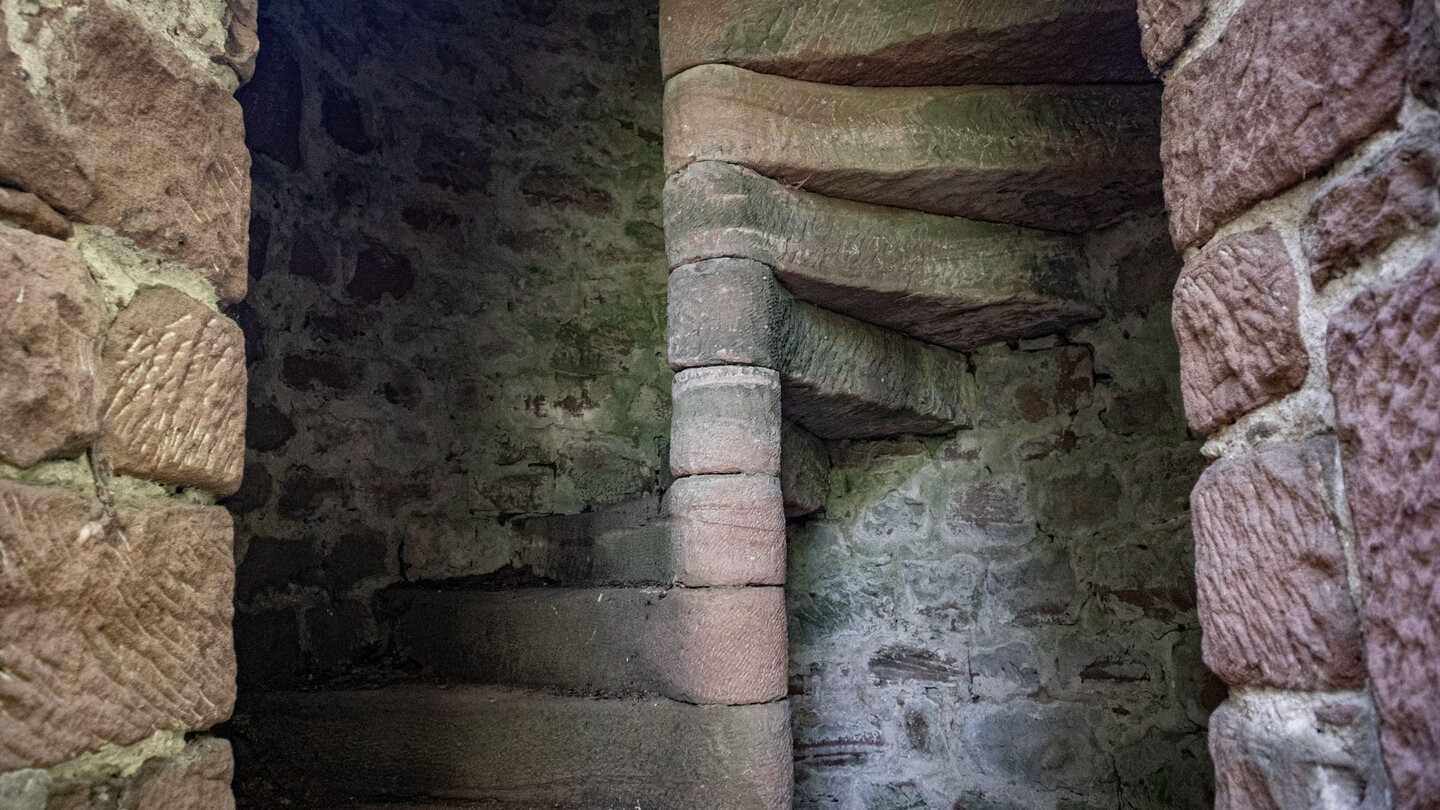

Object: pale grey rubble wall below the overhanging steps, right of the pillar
[788,298,1224,810]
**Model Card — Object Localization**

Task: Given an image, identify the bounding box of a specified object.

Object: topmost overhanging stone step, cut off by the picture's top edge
[660,0,1151,85]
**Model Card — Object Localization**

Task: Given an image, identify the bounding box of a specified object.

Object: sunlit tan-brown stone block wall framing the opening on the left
[0,0,255,810]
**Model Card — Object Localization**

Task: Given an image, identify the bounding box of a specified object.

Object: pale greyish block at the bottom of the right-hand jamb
[1210,692,1388,810]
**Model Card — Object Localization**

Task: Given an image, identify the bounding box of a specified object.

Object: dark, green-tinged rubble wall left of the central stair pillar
[226,0,670,686]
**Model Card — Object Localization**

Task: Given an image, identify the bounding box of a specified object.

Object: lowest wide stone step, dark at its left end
[233,686,792,810]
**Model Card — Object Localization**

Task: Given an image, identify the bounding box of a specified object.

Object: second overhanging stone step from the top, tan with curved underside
[665,65,1161,231]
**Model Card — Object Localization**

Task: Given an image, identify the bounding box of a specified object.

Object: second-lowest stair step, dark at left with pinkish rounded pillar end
[395,582,786,705]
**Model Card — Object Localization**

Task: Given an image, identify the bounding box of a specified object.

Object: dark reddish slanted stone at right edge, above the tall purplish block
[1302,130,1440,287]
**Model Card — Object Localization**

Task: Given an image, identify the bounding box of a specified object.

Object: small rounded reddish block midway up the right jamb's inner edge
[1172,228,1310,434]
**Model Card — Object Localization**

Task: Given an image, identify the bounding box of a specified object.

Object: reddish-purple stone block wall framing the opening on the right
[1140,0,1440,810]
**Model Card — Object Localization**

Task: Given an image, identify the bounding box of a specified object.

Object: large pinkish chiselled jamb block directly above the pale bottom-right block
[1191,438,1365,690]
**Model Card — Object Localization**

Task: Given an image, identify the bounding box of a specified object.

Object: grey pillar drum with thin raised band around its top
[670,366,780,476]
